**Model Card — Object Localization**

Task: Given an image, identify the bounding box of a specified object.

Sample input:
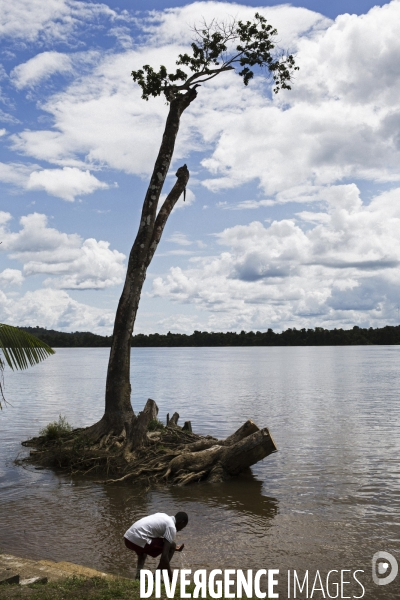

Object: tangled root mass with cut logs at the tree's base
[22,399,277,486]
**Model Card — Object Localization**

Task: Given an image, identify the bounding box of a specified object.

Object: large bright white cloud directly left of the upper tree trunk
[11,48,177,175]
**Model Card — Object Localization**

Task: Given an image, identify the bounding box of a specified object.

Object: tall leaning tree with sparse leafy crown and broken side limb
[86,13,298,443]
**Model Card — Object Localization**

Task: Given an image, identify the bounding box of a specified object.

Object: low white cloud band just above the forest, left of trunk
[0,289,115,335]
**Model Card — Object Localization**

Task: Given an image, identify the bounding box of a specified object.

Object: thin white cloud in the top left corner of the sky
[0,0,117,43]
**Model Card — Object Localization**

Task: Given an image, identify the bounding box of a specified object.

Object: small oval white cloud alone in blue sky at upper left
[11,51,72,89]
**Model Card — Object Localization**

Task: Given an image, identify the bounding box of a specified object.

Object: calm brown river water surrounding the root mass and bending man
[0,346,400,600]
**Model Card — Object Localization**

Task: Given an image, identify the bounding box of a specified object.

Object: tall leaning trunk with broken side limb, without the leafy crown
[87,89,197,438]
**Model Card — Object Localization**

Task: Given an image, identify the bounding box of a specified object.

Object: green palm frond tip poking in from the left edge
[0,323,54,370]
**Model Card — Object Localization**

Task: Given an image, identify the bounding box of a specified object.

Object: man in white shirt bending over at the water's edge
[124,512,189,579]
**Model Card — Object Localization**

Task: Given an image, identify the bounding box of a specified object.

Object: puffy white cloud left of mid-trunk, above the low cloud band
[0,212,125,289]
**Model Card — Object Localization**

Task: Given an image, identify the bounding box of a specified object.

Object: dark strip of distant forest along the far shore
[21,325,400,348]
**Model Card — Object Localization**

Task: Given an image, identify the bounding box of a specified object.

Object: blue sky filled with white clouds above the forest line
[0,0,400,335]
